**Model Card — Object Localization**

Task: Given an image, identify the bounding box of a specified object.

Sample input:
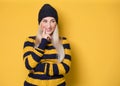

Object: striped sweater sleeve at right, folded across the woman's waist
[37,39,71,76]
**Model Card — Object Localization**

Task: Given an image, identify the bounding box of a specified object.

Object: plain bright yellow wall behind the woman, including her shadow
[0,0,120,86]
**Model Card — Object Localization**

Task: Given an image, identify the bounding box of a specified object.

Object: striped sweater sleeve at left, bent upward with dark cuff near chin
[23,37,47,70]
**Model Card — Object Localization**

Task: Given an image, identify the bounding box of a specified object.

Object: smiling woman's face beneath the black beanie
[40,17,57,35]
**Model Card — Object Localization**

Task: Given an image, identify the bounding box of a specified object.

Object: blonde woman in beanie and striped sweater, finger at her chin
[23,4,71,86]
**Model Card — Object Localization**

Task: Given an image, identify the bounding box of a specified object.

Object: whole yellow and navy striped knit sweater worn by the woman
[23,36,71,86]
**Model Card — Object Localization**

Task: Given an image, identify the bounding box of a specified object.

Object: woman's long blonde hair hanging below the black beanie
[38,24,65,62]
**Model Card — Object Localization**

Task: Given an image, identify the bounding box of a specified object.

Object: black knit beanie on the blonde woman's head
[38,4,58,24]
